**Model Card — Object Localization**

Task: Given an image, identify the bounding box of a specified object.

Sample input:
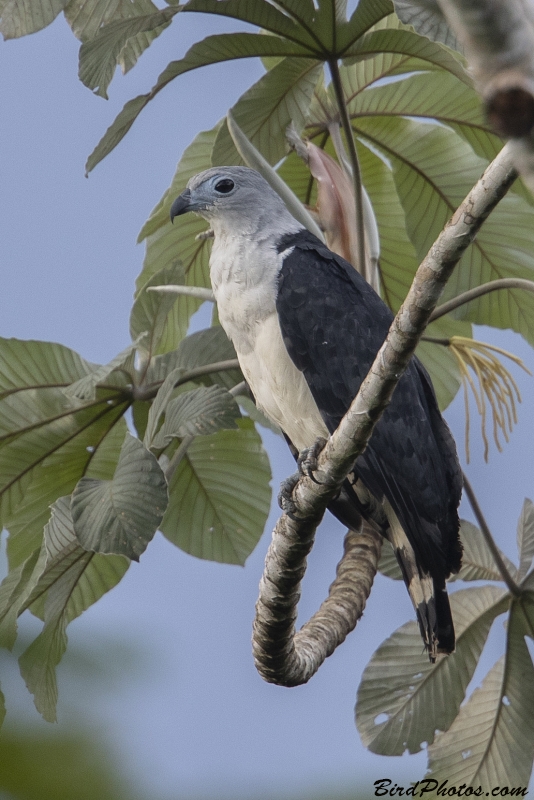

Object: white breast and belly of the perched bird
[210,237,328,450]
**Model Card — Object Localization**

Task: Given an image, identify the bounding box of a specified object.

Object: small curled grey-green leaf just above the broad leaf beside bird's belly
[152,386,241,449]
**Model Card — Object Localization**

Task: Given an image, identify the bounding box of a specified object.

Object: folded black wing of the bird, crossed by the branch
[277,231,462,648]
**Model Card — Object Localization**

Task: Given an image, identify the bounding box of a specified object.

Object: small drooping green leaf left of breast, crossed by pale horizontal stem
[130,262,184,358]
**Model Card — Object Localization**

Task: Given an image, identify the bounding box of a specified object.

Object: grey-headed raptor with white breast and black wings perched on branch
[170,166,462,662]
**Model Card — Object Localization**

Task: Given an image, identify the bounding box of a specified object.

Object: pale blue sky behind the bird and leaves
[0,7,534,798]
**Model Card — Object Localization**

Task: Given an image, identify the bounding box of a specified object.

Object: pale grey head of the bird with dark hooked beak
[171,167,302,235]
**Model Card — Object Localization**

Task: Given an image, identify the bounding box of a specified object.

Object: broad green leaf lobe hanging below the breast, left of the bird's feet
[161,419,271,564]
